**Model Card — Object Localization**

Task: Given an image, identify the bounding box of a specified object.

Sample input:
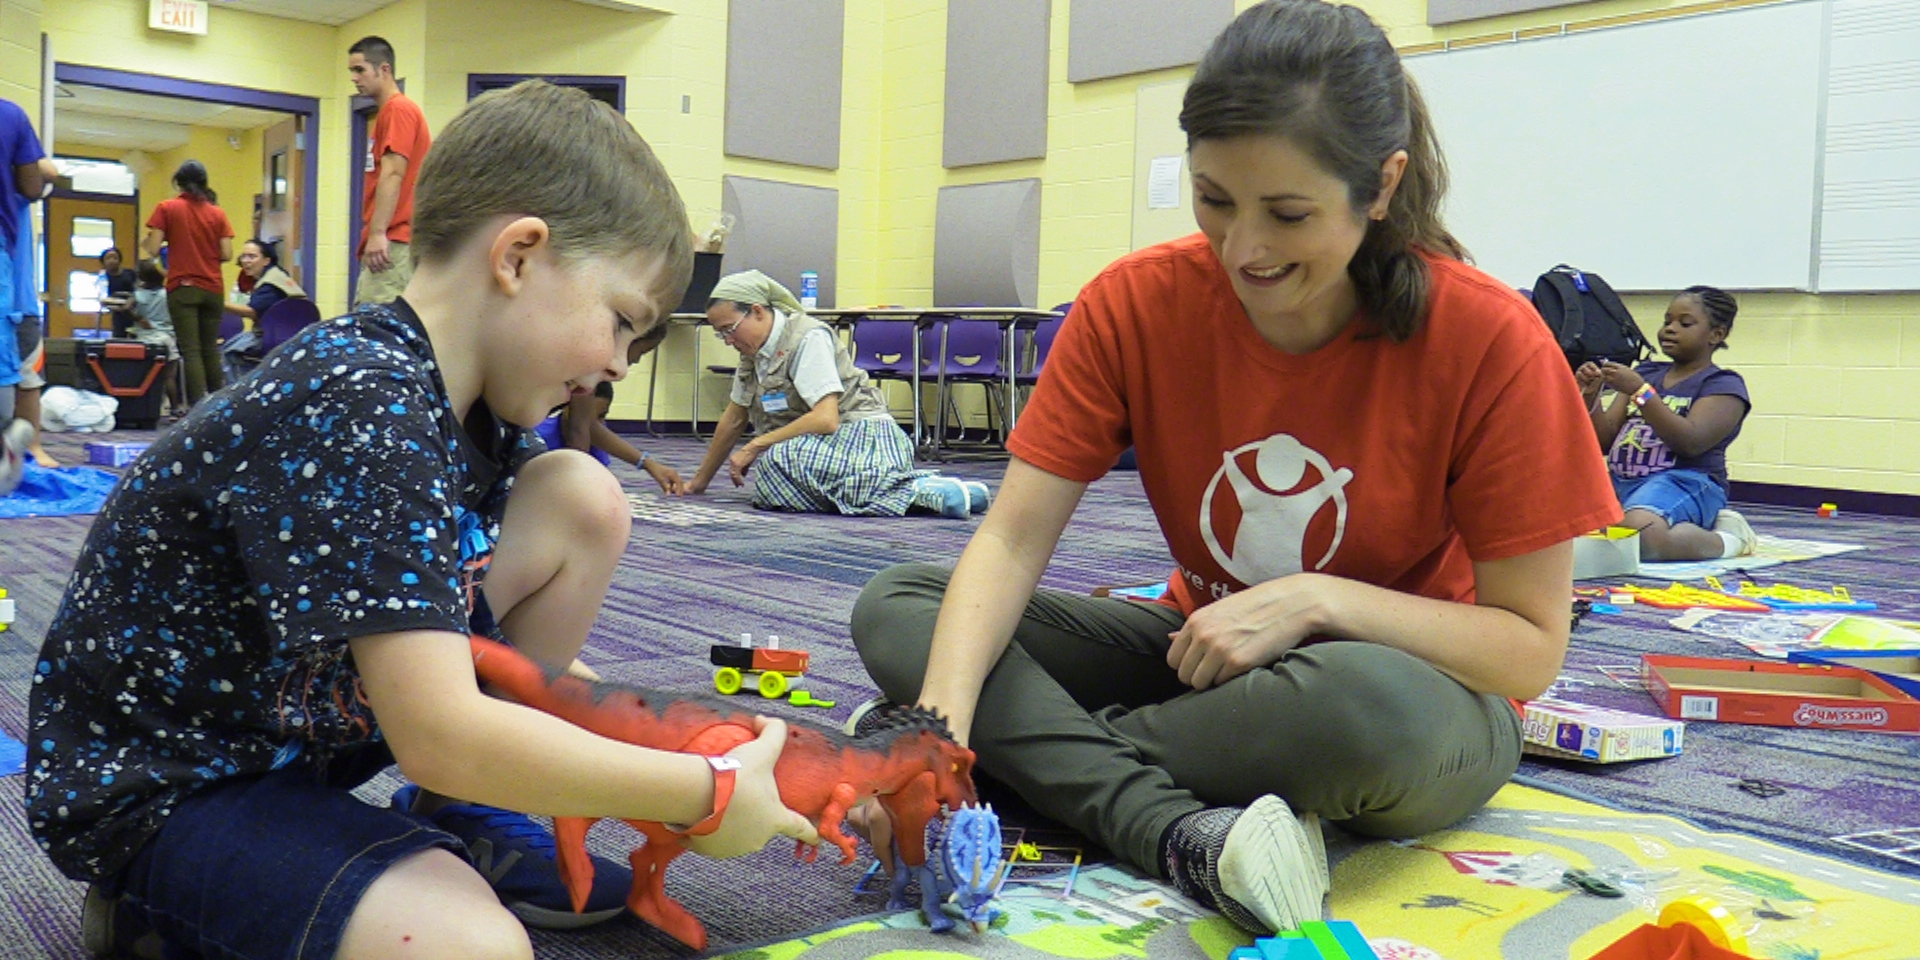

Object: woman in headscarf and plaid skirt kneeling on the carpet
[678,271,991,520]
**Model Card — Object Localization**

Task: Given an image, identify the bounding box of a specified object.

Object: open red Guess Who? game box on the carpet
[1642,653,1920,733]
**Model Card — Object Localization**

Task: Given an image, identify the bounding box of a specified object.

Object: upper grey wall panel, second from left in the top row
[941,0,1052,167]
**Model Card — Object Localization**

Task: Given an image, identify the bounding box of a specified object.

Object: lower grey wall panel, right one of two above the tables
[933,179,1041,307]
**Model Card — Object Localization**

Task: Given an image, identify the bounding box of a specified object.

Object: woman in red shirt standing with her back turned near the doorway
[140,159,234,405]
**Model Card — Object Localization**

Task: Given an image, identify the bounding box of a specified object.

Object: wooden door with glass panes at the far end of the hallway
[46,194,140,338]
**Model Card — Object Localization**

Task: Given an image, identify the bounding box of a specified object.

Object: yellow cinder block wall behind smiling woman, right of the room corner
[879,0,1920,493]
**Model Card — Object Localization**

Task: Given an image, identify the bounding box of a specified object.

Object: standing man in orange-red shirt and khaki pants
[348,36,432,303]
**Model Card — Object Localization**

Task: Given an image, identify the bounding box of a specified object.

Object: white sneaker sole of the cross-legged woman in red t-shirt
[1219,793,1332,931]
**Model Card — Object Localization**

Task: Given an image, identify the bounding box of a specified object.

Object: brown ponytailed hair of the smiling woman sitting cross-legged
[1181,0,1467,340]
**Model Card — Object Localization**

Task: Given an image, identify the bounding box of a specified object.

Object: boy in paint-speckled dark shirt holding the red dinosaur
[23,81,818,960]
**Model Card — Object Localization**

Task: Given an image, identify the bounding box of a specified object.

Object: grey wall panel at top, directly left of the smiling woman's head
[1068,0,1233,83]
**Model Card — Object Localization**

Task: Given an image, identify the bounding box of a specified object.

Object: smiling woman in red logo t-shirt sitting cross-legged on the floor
[852,0,1620,933]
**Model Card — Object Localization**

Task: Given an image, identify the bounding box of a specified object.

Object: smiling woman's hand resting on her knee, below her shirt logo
[1167,574,1344,689]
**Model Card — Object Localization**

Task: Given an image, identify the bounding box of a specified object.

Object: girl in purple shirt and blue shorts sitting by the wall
[1574,286,1753,561]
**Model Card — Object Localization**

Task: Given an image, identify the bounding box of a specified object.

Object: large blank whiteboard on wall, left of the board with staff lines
[1405,0,1822,290]
